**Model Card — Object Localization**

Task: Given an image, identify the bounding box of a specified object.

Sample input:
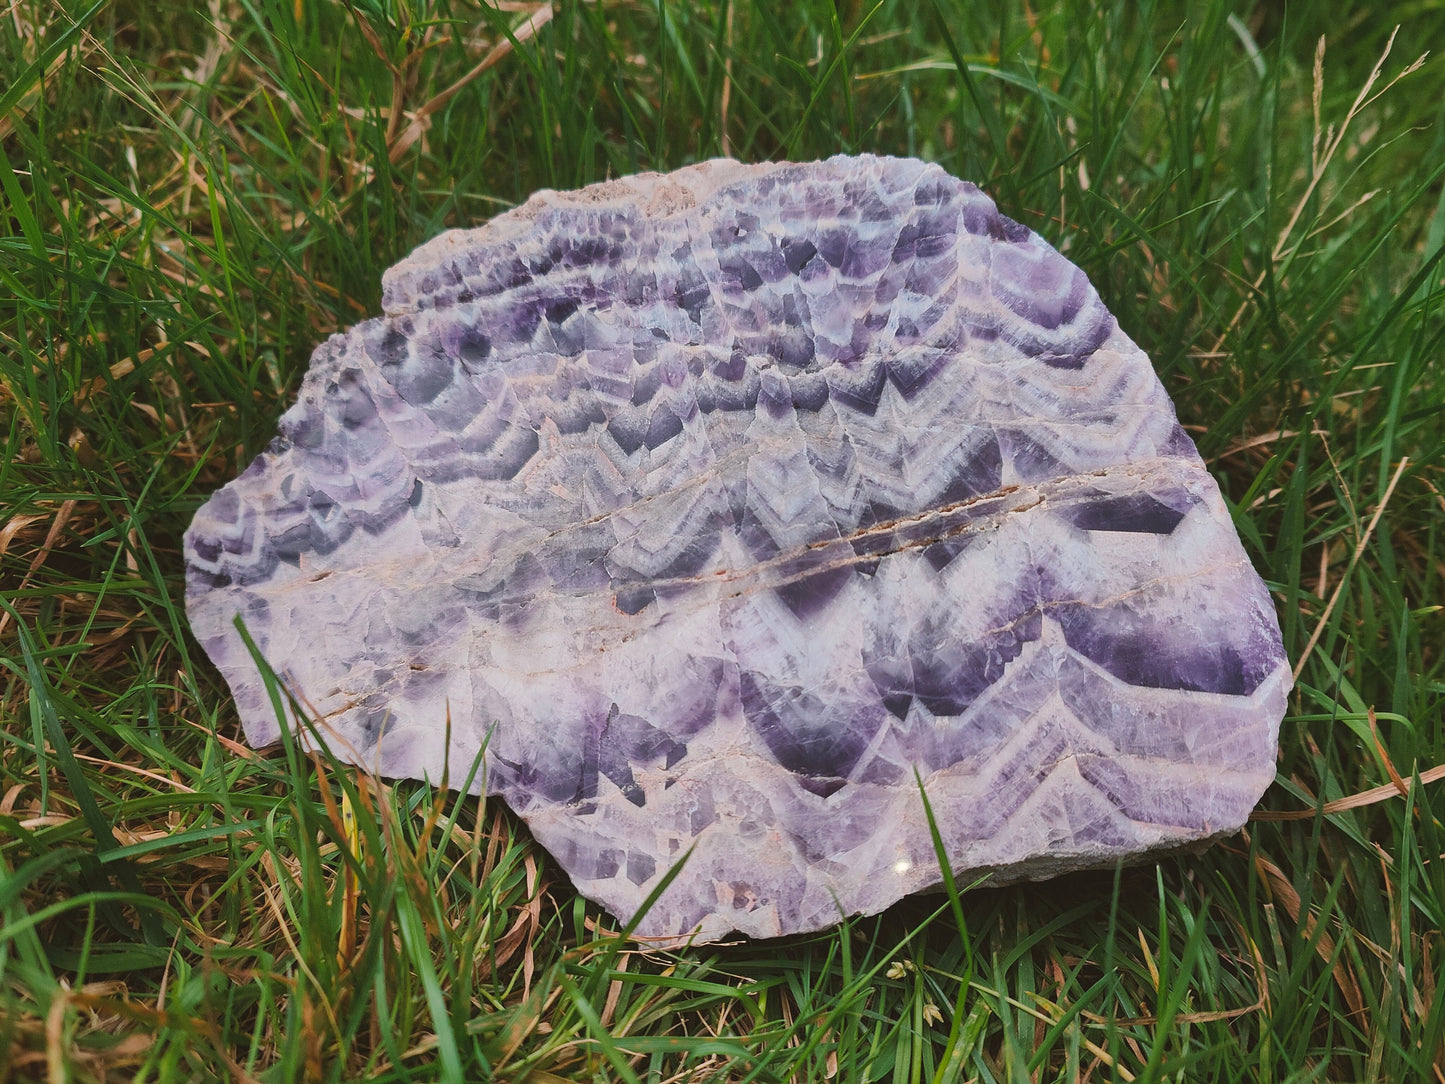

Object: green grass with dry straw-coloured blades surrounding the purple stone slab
[0,0,1445,1084]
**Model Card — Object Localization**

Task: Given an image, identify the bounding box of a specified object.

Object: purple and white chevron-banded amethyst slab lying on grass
[186,158,1290,942]
